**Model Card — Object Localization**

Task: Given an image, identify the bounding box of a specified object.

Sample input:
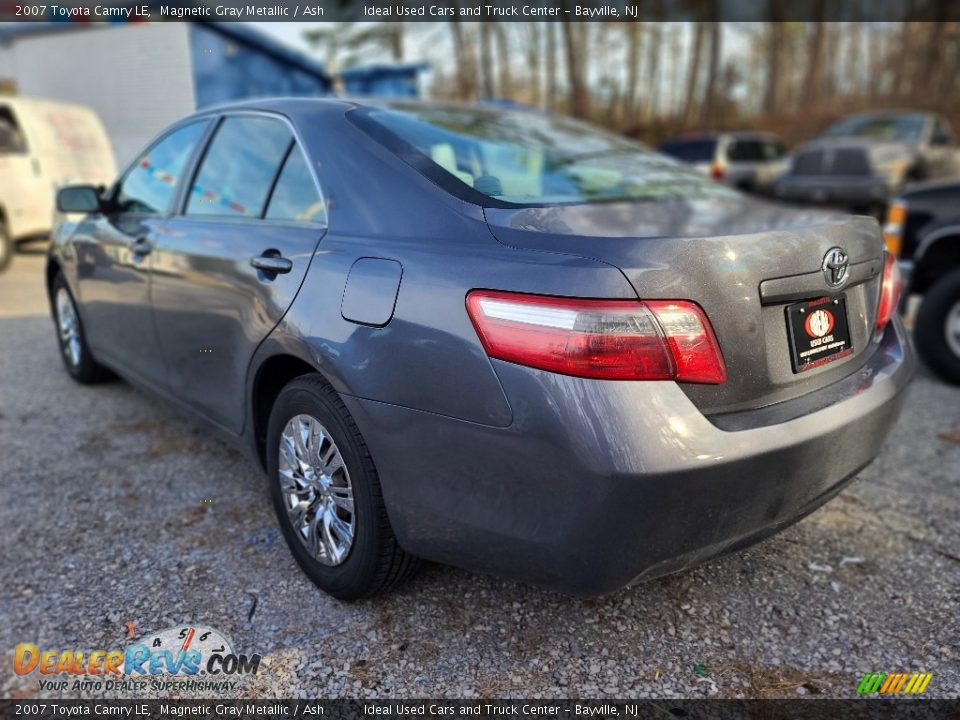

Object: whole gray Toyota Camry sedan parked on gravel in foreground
[46,99,914,598]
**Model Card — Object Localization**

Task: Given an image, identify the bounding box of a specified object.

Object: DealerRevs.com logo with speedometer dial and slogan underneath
[13,625,261,691]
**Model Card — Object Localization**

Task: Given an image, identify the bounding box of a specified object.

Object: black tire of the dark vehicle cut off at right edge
[914,270,960,384]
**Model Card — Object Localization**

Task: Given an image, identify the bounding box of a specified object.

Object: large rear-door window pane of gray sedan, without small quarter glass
[186,116,293,218]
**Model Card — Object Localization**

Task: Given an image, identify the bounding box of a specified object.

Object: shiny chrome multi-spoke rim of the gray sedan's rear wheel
[279,415,356,566]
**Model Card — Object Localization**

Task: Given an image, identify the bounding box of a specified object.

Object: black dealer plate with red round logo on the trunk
[787,295,853,373]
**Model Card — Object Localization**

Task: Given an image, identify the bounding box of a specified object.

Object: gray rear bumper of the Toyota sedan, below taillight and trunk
[344,320,914,595]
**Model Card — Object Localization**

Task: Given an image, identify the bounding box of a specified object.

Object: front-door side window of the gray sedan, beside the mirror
[116,120,207,215]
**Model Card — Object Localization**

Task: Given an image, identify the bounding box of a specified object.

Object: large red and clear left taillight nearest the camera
[467,290,727,383]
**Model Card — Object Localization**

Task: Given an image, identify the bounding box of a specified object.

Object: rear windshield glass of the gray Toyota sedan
[368,103,732,205]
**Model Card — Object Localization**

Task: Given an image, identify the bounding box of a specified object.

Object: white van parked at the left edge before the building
[0,96,117,270]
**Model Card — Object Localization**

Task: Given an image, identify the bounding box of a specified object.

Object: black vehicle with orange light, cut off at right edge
[884,180,960,383]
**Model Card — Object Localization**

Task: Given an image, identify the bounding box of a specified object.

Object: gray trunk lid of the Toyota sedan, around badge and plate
[486,195,883,414]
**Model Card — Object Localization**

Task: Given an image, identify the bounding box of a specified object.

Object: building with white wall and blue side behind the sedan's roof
[0,22,333,166]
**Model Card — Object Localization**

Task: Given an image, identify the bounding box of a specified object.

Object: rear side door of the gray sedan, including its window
[152,113,326,433]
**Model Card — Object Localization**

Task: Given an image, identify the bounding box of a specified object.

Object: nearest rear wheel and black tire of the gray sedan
[267,374,418,600]
